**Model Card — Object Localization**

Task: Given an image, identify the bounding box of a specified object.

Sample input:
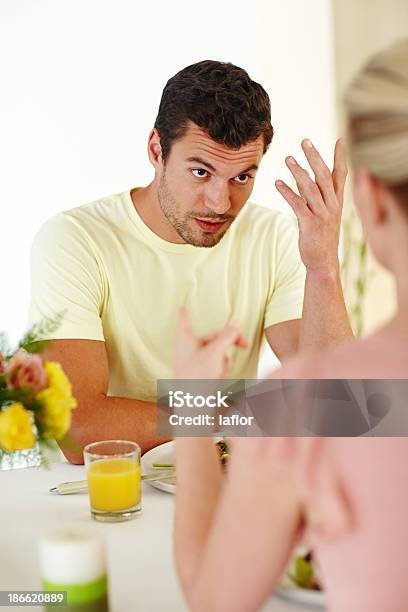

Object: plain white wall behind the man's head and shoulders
[0,0,335,354]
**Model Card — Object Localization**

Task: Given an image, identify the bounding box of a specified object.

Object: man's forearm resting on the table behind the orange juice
[60,395,168,464]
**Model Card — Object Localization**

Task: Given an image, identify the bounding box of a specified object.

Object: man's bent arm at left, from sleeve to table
[44,340,171,463]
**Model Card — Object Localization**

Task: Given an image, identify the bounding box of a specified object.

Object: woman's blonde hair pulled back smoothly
[345,38,408,189]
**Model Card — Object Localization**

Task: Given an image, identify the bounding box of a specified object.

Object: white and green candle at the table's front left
[39,528,108,612]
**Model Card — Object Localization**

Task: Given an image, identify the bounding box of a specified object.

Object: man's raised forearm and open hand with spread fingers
[274,140,353,351]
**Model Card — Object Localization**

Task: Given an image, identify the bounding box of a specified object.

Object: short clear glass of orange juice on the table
[84,440,142,523]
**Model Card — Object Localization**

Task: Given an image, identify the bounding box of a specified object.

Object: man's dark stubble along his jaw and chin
[157,171,231,248]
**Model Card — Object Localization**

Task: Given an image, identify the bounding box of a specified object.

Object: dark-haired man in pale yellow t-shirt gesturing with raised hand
[30,61,351,463]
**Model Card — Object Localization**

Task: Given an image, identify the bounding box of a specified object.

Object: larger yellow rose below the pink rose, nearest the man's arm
[36,361,77,440]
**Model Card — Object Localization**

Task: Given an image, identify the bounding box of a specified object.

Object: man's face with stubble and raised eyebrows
[158,123,263,247]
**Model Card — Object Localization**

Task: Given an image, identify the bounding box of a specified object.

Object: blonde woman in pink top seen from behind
[175,40,408,612]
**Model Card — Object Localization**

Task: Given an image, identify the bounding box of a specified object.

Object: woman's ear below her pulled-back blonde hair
[354,168,389,226]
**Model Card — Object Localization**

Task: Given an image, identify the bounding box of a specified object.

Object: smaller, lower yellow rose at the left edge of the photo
[0,403,35,452]
